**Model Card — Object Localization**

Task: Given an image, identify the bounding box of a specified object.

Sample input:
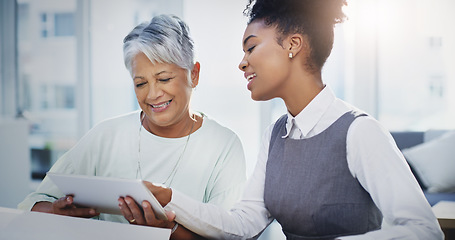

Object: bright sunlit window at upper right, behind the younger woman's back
[375,0,455,130]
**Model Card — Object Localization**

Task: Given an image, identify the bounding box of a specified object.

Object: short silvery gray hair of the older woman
[123,15,194,82]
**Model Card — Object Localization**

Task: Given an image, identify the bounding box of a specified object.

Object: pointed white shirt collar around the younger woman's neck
[283,86,336,138]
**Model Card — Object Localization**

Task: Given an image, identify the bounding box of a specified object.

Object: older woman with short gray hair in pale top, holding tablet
[19,15,246,238]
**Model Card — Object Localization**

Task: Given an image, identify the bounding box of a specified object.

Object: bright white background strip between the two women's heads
[183,0,263,172]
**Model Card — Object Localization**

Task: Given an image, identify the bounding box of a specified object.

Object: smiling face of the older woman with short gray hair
[132,52,197,128]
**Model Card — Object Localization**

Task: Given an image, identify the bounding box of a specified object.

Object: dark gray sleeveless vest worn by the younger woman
[264,112,382,240]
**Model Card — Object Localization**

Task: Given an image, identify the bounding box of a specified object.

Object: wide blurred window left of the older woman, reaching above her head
[17,0,183,179]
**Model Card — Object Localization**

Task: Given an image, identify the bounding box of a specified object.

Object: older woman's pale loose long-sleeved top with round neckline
[19,111,246,222]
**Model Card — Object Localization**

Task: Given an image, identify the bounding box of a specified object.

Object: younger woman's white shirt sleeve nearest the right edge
[339,117,443,240]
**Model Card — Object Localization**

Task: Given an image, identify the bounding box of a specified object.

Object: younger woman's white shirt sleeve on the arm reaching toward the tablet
[165,124,273,239]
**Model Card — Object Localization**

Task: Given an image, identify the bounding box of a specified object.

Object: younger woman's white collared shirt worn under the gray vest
[166,87,443,240]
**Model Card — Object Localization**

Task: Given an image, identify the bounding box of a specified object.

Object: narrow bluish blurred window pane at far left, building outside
[17,0,79,178]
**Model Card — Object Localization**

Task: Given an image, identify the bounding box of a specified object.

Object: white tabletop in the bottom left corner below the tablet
[0,207,171,240]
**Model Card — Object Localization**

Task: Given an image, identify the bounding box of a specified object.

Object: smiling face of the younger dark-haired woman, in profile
[239,20,290,100]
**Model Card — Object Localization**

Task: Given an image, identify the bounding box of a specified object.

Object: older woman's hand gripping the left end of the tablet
[32,195,99,218]
